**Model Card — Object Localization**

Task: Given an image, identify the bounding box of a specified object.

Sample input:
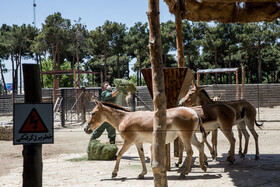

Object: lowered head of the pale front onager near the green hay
[84,100,105,134]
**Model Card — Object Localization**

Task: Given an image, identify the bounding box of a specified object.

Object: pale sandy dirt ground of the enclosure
[0,108,280,187]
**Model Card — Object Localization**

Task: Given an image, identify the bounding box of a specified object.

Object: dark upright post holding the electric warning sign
[22,64,43,187]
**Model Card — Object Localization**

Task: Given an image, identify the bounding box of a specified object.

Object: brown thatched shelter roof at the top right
[164,0,280,23]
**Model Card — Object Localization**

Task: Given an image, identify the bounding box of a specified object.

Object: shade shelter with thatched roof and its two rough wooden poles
[147,0,280,186]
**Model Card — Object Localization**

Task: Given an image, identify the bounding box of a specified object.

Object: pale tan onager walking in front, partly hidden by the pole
[84,100,206,179]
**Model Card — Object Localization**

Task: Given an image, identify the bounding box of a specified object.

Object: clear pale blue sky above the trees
[0,0,175,83]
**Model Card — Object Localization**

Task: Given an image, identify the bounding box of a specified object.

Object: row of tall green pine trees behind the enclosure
[0,12,280,91]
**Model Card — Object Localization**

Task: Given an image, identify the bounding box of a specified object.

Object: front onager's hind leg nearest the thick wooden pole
[180,133,193,176]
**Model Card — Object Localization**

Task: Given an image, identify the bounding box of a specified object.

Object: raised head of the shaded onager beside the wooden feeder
[179,85,203,107]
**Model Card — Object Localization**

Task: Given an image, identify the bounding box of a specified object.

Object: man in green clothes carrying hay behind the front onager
[90,81,118,144]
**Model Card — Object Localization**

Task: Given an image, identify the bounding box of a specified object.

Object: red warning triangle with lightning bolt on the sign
[19,108,49,133]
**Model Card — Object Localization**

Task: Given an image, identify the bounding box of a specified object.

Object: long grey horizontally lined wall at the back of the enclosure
[0,84,280,115]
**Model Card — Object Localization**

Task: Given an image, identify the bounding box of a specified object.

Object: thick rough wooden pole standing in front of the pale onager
[147,0,167,187]
